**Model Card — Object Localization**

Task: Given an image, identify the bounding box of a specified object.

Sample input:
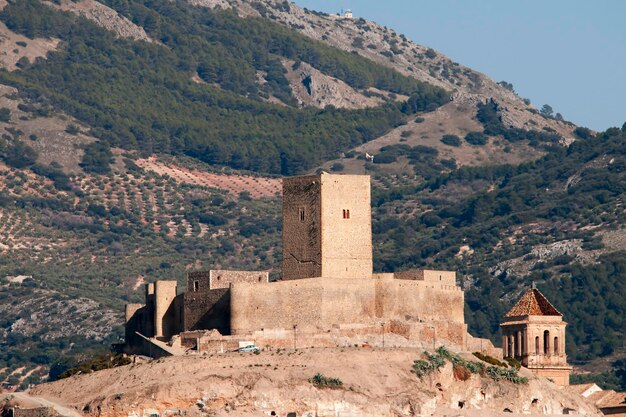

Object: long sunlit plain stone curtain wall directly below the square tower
[230,278,465,334]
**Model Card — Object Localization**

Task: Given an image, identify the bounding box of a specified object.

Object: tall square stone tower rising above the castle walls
[282,172,373,280]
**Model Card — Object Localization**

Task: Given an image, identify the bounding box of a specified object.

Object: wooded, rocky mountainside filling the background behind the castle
[0,0,626,392]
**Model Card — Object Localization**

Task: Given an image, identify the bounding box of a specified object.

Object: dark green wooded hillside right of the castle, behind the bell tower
[373,124,626,361]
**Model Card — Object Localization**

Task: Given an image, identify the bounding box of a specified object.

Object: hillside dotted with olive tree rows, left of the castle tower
[0,159,280,380]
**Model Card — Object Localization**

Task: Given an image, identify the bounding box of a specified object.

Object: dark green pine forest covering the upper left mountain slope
[0,0,449,175]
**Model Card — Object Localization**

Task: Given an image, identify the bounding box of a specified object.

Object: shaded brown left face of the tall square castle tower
[282,175,322,280]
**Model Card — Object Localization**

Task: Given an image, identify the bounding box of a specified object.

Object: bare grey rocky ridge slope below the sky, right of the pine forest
[190,0,575,173]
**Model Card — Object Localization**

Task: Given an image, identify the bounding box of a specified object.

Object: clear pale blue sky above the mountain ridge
[295,0,626,130]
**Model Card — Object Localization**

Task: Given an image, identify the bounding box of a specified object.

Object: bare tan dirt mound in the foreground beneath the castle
[31,348,598,417]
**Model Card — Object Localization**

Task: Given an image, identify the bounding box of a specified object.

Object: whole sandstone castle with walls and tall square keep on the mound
[125,173,568,384]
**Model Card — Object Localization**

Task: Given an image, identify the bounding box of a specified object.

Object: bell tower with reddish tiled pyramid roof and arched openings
[500,283,572,386]
